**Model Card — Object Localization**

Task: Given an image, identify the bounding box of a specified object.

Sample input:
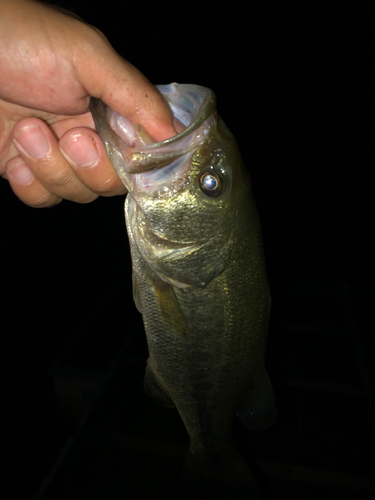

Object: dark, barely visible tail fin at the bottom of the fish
[183,448,262,500]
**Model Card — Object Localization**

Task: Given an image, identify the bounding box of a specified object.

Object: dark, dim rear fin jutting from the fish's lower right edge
[238,371,277,431]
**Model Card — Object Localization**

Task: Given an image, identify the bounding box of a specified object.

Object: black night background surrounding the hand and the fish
[0,0,375,500]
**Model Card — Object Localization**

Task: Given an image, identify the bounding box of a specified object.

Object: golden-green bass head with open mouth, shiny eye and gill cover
[92,84,250,288]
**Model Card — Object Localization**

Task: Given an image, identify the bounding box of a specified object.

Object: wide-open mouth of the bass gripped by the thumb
[90,83,216,184]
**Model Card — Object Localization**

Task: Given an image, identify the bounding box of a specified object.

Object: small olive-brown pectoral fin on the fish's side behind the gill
[153,280,189,338]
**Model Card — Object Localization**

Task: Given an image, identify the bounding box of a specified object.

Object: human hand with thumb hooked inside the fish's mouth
[0,0,176,207]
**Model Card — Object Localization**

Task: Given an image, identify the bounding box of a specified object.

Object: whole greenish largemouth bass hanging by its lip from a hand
[90,83,276,499]
